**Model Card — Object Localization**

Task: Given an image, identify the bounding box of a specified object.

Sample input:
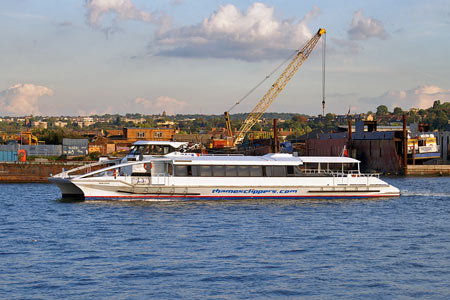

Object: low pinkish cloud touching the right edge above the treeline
[360,85,450,110]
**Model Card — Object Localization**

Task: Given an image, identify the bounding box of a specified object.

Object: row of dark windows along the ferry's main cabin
[173,165,322,177]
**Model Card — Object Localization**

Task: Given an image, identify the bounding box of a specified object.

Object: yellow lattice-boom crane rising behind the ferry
[224,28,326,146]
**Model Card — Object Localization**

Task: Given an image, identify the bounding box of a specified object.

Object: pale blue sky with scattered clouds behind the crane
[0,0,450,116]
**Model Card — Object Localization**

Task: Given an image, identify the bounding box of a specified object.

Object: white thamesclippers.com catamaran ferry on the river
[49,142,400,201]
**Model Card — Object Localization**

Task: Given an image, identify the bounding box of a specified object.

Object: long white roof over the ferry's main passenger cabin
[164,153,359,166]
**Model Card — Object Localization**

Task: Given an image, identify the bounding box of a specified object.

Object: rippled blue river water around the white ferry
[0,177,450,299]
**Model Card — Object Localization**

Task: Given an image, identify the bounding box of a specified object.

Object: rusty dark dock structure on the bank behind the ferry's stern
[305,120,450,176]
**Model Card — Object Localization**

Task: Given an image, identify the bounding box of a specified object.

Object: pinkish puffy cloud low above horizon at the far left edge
[0,83,54,116]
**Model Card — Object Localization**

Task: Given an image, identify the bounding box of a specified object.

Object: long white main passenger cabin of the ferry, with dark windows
[148,154,360,177]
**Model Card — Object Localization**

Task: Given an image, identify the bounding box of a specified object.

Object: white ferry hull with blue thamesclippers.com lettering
[51,177,399,201]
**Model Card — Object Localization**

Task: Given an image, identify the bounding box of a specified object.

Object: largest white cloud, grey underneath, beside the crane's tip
[152,2,320,60]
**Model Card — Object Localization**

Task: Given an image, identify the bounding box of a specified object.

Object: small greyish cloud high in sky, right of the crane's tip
[347,9,387,40]
